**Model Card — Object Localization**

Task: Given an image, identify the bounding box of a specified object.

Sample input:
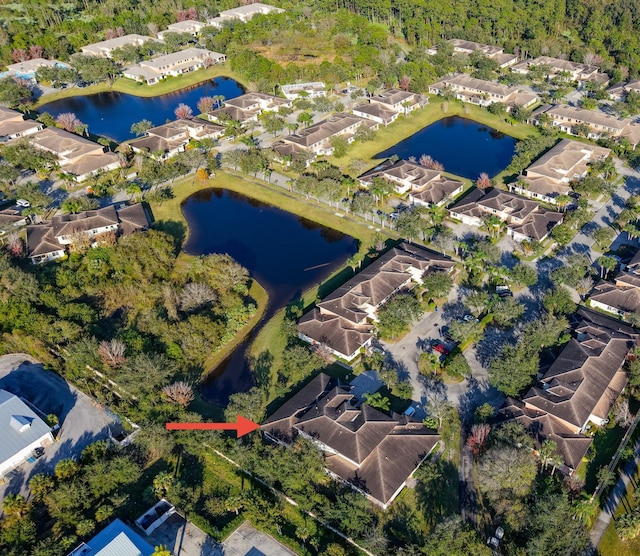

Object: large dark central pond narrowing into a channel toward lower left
[182,188,357,406]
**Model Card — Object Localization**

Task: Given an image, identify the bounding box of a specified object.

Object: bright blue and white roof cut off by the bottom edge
[68,519,155,556]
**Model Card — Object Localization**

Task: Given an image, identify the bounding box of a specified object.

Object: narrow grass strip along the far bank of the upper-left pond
[34,64,246,109]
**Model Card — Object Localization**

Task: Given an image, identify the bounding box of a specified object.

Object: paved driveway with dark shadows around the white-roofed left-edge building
[0,353,122,500]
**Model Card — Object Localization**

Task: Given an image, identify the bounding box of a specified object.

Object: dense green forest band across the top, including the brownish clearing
[0,0,640,90]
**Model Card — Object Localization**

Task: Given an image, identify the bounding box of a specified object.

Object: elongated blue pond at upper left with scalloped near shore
[38,77,244,142]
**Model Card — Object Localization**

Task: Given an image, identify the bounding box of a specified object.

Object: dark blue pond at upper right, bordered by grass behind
[376,116,516,180]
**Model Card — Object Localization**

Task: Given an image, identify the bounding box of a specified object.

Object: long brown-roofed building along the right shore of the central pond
[298,243,454,361]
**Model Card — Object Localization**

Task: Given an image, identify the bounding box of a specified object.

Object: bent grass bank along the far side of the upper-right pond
[329,96,538,175]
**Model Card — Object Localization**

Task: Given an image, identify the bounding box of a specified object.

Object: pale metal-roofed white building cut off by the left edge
[0,390,53,478]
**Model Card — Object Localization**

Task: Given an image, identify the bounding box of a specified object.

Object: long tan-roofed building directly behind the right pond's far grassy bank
[429,74,540,110]
